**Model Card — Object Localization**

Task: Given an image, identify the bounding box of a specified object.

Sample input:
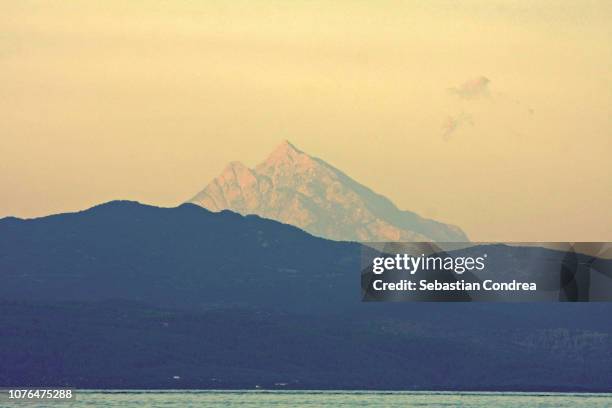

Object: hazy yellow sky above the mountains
[0,0,612,241]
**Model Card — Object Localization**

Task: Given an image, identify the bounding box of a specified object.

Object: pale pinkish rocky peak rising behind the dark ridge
[189,141,468,242]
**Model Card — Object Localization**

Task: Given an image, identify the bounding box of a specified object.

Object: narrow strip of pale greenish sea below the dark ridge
[2,390,612,408]
